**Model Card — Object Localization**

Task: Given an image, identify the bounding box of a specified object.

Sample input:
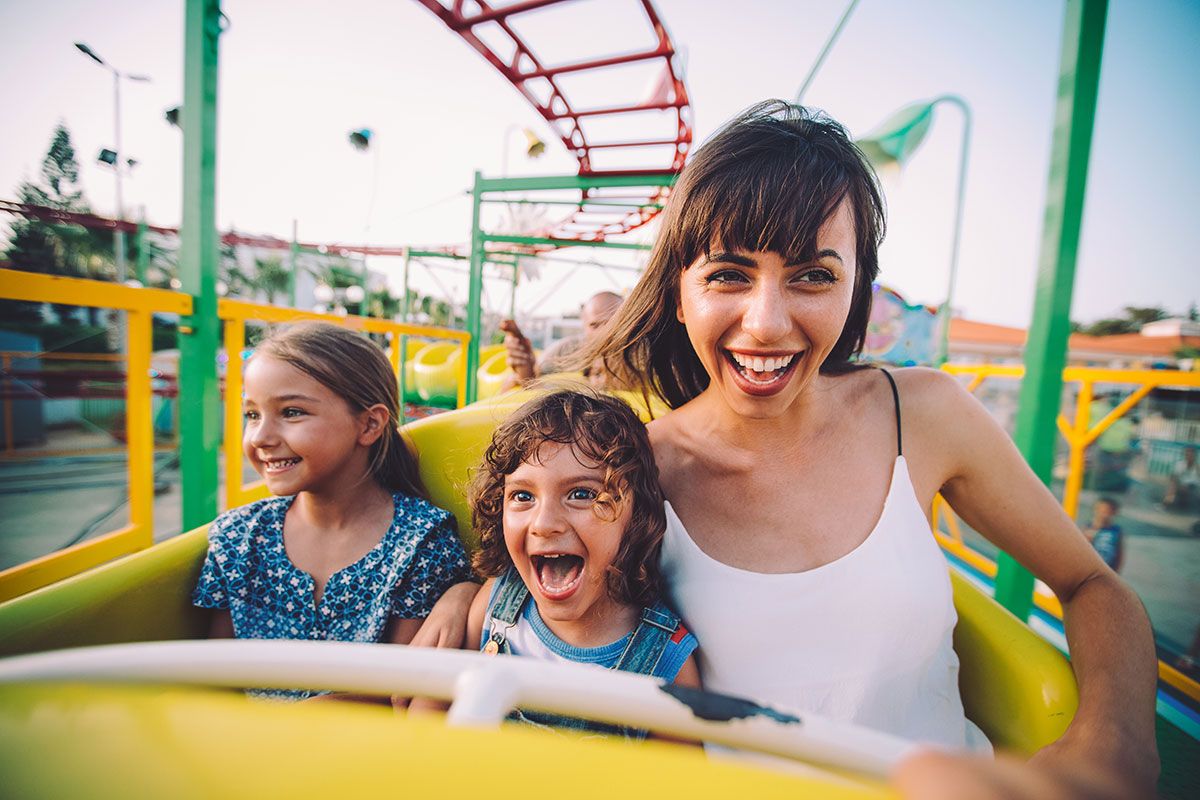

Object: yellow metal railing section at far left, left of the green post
[0,270,192,601]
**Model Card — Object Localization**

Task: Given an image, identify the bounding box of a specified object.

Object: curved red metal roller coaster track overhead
[418,0,692,240]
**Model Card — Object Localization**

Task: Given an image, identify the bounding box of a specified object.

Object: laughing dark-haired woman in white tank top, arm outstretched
[581,101,1158,796]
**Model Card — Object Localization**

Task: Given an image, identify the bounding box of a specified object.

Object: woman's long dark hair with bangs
[578,100,884,408]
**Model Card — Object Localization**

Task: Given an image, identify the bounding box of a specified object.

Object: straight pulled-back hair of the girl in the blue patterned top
[256,321,428,500]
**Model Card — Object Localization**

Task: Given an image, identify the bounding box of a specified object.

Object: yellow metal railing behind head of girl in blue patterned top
[217,300,470,509]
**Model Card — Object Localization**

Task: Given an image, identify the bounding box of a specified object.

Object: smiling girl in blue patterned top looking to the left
[192,323,470,698]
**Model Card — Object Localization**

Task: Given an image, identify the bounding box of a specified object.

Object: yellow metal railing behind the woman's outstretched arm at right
[930,363,1200,700]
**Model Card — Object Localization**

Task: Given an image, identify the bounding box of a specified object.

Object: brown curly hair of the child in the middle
[468,387,666,607]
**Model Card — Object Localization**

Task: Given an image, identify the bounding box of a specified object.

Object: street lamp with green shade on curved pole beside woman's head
[857,95,971,366]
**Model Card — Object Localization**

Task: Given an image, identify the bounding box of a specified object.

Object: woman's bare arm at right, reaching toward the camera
[900,371,1158,796]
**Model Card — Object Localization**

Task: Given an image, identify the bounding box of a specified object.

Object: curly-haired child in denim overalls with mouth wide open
[467,391,700,739]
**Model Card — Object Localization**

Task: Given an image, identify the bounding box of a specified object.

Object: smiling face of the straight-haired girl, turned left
[242,354,379,495]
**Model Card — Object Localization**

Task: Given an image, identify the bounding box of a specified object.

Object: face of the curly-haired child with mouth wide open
[504,443,632,644]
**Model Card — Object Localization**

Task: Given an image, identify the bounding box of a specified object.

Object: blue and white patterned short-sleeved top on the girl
[192,492,472,697]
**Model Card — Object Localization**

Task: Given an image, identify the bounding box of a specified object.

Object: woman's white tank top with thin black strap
[662,375,990,750]
